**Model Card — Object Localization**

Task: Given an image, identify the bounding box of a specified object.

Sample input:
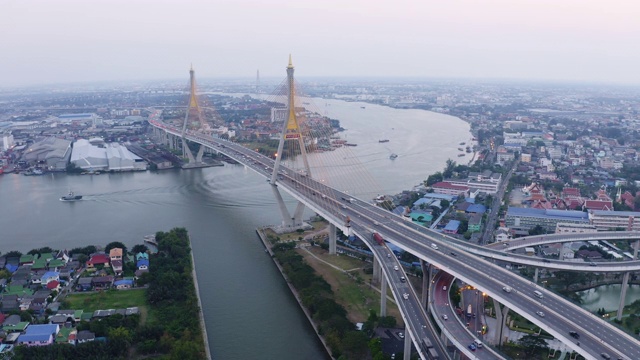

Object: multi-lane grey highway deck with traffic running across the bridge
[150,121,640,360]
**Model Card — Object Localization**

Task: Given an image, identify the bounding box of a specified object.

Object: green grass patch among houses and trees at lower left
[65,289,149,323]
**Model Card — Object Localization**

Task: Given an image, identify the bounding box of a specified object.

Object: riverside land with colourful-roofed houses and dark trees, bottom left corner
[0,228,209,360]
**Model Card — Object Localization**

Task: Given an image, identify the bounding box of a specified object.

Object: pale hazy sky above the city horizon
[0,0,640,87]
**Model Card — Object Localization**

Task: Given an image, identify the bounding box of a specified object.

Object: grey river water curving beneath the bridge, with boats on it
[0,100,470,359]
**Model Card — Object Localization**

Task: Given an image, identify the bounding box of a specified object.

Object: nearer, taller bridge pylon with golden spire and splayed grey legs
[270,55,311,227]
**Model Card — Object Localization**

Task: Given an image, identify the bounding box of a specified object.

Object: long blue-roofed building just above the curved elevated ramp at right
[505,206,589,233]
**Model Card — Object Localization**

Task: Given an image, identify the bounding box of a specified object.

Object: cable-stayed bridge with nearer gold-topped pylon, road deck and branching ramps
[149,61,640,360]
